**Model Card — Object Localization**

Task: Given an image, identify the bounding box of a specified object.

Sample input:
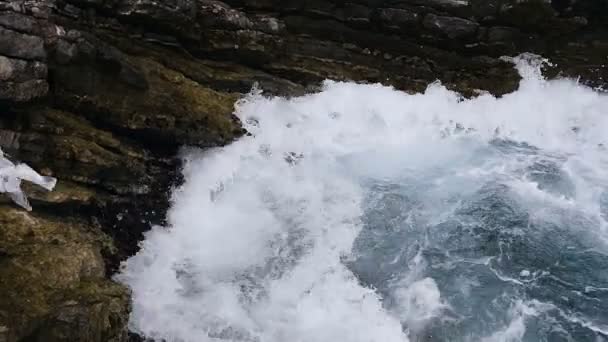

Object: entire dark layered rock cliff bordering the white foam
[0,0,608,342]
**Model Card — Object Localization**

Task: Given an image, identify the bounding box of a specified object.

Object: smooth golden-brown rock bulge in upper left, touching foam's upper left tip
[54,52,238,146]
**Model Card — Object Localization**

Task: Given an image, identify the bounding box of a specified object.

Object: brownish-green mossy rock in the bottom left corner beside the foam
[0,205,129,342]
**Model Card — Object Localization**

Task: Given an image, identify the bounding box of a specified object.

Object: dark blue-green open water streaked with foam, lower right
[349,178,608,342]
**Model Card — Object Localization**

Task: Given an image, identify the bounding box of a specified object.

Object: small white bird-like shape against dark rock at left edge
[0,150,57,211]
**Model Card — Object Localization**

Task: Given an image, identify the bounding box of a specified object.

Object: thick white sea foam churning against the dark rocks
[117,58,608,342]
